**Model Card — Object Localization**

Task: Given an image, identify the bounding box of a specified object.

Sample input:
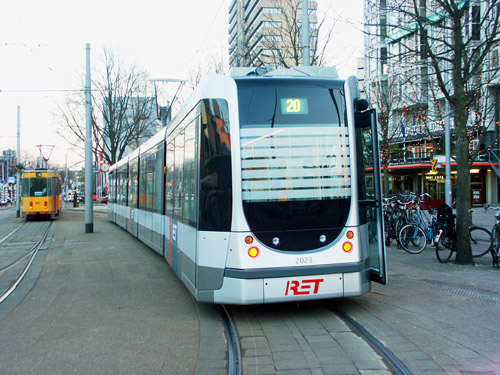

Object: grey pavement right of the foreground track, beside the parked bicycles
[342,208,500,375]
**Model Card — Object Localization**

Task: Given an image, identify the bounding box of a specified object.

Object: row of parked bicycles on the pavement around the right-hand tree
[383,193,500,267]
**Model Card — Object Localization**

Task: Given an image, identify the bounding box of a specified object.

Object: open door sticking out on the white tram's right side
[355,99,387,284]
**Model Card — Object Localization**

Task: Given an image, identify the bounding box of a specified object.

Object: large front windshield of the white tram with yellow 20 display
[237,79,351,250]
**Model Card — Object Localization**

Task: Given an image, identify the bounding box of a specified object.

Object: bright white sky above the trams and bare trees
[0,0,363,169]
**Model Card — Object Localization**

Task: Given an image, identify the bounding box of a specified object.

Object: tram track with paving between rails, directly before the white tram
[225,301,411,375]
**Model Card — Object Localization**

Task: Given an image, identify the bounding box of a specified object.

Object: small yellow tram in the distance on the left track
[21,168,62,219]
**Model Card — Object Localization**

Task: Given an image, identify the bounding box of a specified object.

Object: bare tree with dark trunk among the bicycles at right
[372,0,500,264]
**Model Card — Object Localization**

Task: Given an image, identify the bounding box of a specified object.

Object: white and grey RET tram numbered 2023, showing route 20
[108,67,386,304]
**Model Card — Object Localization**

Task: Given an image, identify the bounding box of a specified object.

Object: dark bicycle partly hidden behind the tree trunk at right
[435,203,492,263]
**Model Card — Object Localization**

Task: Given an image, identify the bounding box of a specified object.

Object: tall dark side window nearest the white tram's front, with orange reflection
[199,99,232,231]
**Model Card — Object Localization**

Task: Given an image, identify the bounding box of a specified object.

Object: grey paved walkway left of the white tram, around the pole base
[0,210,200,375]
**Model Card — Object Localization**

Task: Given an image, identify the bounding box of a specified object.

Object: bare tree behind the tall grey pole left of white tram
[58,48,158,164]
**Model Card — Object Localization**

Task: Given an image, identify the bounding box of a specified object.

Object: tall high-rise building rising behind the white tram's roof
[229,0,318,68]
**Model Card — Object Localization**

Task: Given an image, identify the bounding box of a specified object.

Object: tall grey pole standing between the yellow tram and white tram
[85,43,94,233]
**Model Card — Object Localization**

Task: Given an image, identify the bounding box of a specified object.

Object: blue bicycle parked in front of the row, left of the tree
[399,194,439,254]
